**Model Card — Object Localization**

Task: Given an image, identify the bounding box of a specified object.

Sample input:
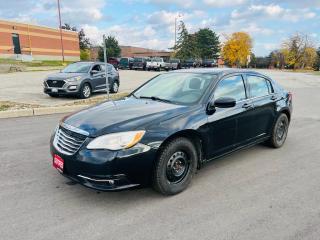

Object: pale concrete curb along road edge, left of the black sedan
[0,105,90,119]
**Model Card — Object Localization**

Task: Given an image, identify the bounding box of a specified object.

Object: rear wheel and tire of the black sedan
[268,113,289,148]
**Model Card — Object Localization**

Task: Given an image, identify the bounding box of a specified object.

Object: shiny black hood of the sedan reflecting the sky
[63,98,190,137]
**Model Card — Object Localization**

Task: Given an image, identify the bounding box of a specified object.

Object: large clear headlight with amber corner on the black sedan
[87,131,145,151]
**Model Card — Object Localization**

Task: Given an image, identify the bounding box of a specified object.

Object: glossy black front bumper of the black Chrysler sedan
[51,138,157,191]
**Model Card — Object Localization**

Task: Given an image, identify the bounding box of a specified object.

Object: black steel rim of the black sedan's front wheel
[166,151,190,183]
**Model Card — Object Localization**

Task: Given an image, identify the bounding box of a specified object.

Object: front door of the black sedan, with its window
[208,74,247,158]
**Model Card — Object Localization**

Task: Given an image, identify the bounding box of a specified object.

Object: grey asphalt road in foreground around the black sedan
[0,72,320,240]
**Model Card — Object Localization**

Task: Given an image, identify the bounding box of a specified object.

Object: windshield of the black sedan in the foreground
[133,73,217,105]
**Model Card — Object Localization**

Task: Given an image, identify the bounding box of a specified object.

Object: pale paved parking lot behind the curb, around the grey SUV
[0,70,320,106]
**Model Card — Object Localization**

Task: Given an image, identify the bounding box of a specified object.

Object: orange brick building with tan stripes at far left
[0,20,80,61]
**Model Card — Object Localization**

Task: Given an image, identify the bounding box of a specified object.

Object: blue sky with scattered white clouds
[0,0,320,56]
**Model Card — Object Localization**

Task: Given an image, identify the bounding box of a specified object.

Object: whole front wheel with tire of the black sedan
[153,137,198,195]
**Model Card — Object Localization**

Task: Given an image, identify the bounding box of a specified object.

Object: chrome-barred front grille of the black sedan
[53,126,87,155]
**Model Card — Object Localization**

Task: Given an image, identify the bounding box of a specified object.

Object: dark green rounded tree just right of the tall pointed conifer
[195,28,220,60]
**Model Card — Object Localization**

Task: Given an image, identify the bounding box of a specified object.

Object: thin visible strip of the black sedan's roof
[173,68,264,76]
